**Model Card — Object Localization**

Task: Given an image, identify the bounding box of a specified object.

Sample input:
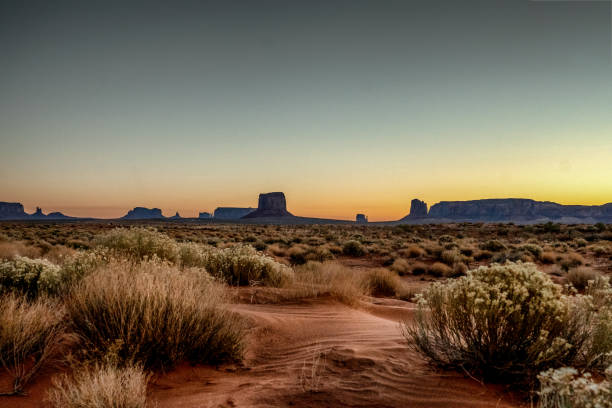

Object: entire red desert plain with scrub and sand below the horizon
[0,222,612,408]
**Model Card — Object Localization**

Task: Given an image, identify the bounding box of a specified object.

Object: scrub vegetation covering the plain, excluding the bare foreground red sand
[0,222,612,408]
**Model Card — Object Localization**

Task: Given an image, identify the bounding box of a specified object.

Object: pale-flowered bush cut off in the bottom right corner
[538,365,612,408]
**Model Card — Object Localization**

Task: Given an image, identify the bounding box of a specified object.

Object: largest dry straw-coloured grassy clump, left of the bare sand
[66,261,243,368]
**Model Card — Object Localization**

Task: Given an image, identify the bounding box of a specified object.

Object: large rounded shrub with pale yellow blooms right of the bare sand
[403,263,582,381]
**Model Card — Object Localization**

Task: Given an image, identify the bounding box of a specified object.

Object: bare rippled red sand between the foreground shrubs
[0,298,521,408]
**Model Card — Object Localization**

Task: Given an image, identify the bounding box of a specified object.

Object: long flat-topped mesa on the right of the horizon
[428,198,612,221]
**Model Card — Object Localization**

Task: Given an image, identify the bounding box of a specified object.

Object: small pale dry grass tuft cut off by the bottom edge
[47,364,148,408]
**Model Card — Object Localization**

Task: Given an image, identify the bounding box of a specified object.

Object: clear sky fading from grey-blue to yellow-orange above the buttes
[0,0,612,220]
